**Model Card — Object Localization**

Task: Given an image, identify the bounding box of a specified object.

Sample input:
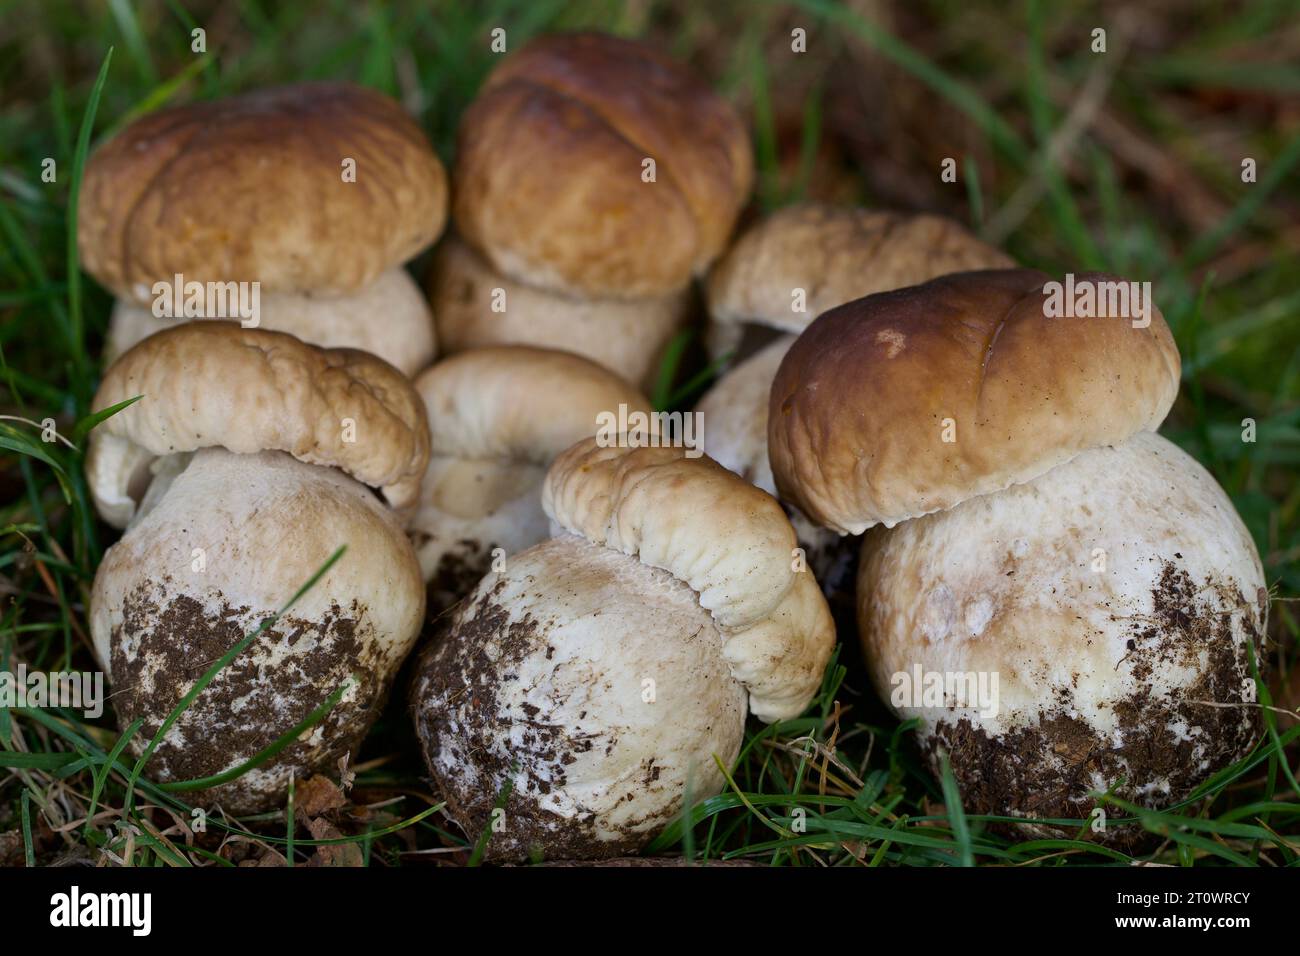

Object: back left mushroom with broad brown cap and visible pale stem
[77,83,447,375]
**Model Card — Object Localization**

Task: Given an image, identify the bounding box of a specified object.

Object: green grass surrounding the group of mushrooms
[0,0,1300,866]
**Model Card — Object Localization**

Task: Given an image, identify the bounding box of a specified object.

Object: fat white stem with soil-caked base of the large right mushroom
[858,432,1268,842]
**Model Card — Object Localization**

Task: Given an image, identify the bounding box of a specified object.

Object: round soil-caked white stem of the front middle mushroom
[411,535,746,860]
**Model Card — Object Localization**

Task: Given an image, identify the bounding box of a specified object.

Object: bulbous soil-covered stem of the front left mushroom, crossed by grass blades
[90,447,424,813]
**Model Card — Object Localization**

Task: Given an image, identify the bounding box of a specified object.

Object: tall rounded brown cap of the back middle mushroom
[452,33,754,299]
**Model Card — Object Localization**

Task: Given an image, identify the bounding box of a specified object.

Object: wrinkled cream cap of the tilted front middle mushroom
[542,438,835,722]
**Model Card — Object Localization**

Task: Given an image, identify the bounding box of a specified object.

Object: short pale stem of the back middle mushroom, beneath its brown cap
[428,235,690,388]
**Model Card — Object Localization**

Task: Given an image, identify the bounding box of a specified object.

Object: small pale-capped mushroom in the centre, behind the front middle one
[413,346,654,611]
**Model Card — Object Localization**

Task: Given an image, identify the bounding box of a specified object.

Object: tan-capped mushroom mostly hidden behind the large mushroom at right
[698,203,1013,606]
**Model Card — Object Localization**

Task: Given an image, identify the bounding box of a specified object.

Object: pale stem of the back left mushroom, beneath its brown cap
[104,268,437,376]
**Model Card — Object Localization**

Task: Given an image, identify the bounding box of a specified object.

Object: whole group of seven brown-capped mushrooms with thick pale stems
[78,22,1268,861]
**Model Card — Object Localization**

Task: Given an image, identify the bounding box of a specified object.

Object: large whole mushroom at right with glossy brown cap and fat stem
[768,269,1266,843]
